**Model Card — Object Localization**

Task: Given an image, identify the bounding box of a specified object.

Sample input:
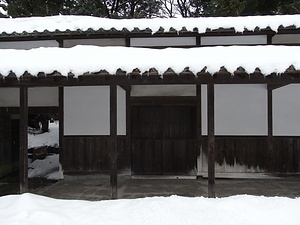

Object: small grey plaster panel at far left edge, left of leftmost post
[0,88,20,107]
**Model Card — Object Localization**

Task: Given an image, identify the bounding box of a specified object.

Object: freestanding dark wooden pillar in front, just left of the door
[110,84,118,199]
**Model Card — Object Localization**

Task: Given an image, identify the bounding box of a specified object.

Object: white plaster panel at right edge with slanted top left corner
[273,84,300,136]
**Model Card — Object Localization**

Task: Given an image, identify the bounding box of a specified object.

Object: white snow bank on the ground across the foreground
[0,194,300,225]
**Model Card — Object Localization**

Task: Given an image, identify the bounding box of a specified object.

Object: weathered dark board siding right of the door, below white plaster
[203,136,300,173]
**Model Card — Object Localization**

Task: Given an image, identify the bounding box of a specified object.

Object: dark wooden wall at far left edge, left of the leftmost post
[0,115,13,177]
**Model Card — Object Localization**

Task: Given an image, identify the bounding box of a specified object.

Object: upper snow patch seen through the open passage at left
[28,121,59,148]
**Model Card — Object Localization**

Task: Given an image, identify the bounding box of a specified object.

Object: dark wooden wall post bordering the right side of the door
[196,84,202,178]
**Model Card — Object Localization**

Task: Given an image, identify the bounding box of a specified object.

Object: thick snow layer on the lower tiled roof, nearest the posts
[0,46,300,77]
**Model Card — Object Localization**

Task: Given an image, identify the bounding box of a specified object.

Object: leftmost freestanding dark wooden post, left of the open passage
[19,87,28,194]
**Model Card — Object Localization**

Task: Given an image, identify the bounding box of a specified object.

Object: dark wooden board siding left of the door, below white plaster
[62,136,130,173]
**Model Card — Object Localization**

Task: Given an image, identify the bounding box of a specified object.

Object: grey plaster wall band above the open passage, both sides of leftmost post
[0,87,58,107]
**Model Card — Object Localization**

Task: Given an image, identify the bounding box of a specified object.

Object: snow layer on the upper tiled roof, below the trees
[0,15,300,36]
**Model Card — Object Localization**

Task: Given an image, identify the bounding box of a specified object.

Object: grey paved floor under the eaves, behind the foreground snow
[0,175,300,201]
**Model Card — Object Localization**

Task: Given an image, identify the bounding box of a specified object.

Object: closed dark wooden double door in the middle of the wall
[131,106,196,175]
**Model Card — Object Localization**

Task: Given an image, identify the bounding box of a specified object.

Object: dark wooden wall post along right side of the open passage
[58,87,64,168]
